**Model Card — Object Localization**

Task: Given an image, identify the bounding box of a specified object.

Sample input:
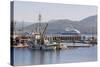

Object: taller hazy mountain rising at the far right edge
[75,15,97,33]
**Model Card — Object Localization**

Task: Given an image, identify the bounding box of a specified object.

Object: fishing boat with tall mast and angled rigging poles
[27,14,60,50]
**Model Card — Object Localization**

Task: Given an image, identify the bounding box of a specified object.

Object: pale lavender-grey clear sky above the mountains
[14,1,97,22]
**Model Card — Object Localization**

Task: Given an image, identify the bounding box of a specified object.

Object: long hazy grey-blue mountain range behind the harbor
[15,15,97,33]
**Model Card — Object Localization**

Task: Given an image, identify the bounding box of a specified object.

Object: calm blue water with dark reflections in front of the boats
[14,46,97,65]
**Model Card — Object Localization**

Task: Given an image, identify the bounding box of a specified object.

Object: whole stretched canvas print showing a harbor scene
[10,1,98,66]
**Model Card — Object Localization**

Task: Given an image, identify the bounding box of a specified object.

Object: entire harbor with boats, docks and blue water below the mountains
[11,14,97,66]
